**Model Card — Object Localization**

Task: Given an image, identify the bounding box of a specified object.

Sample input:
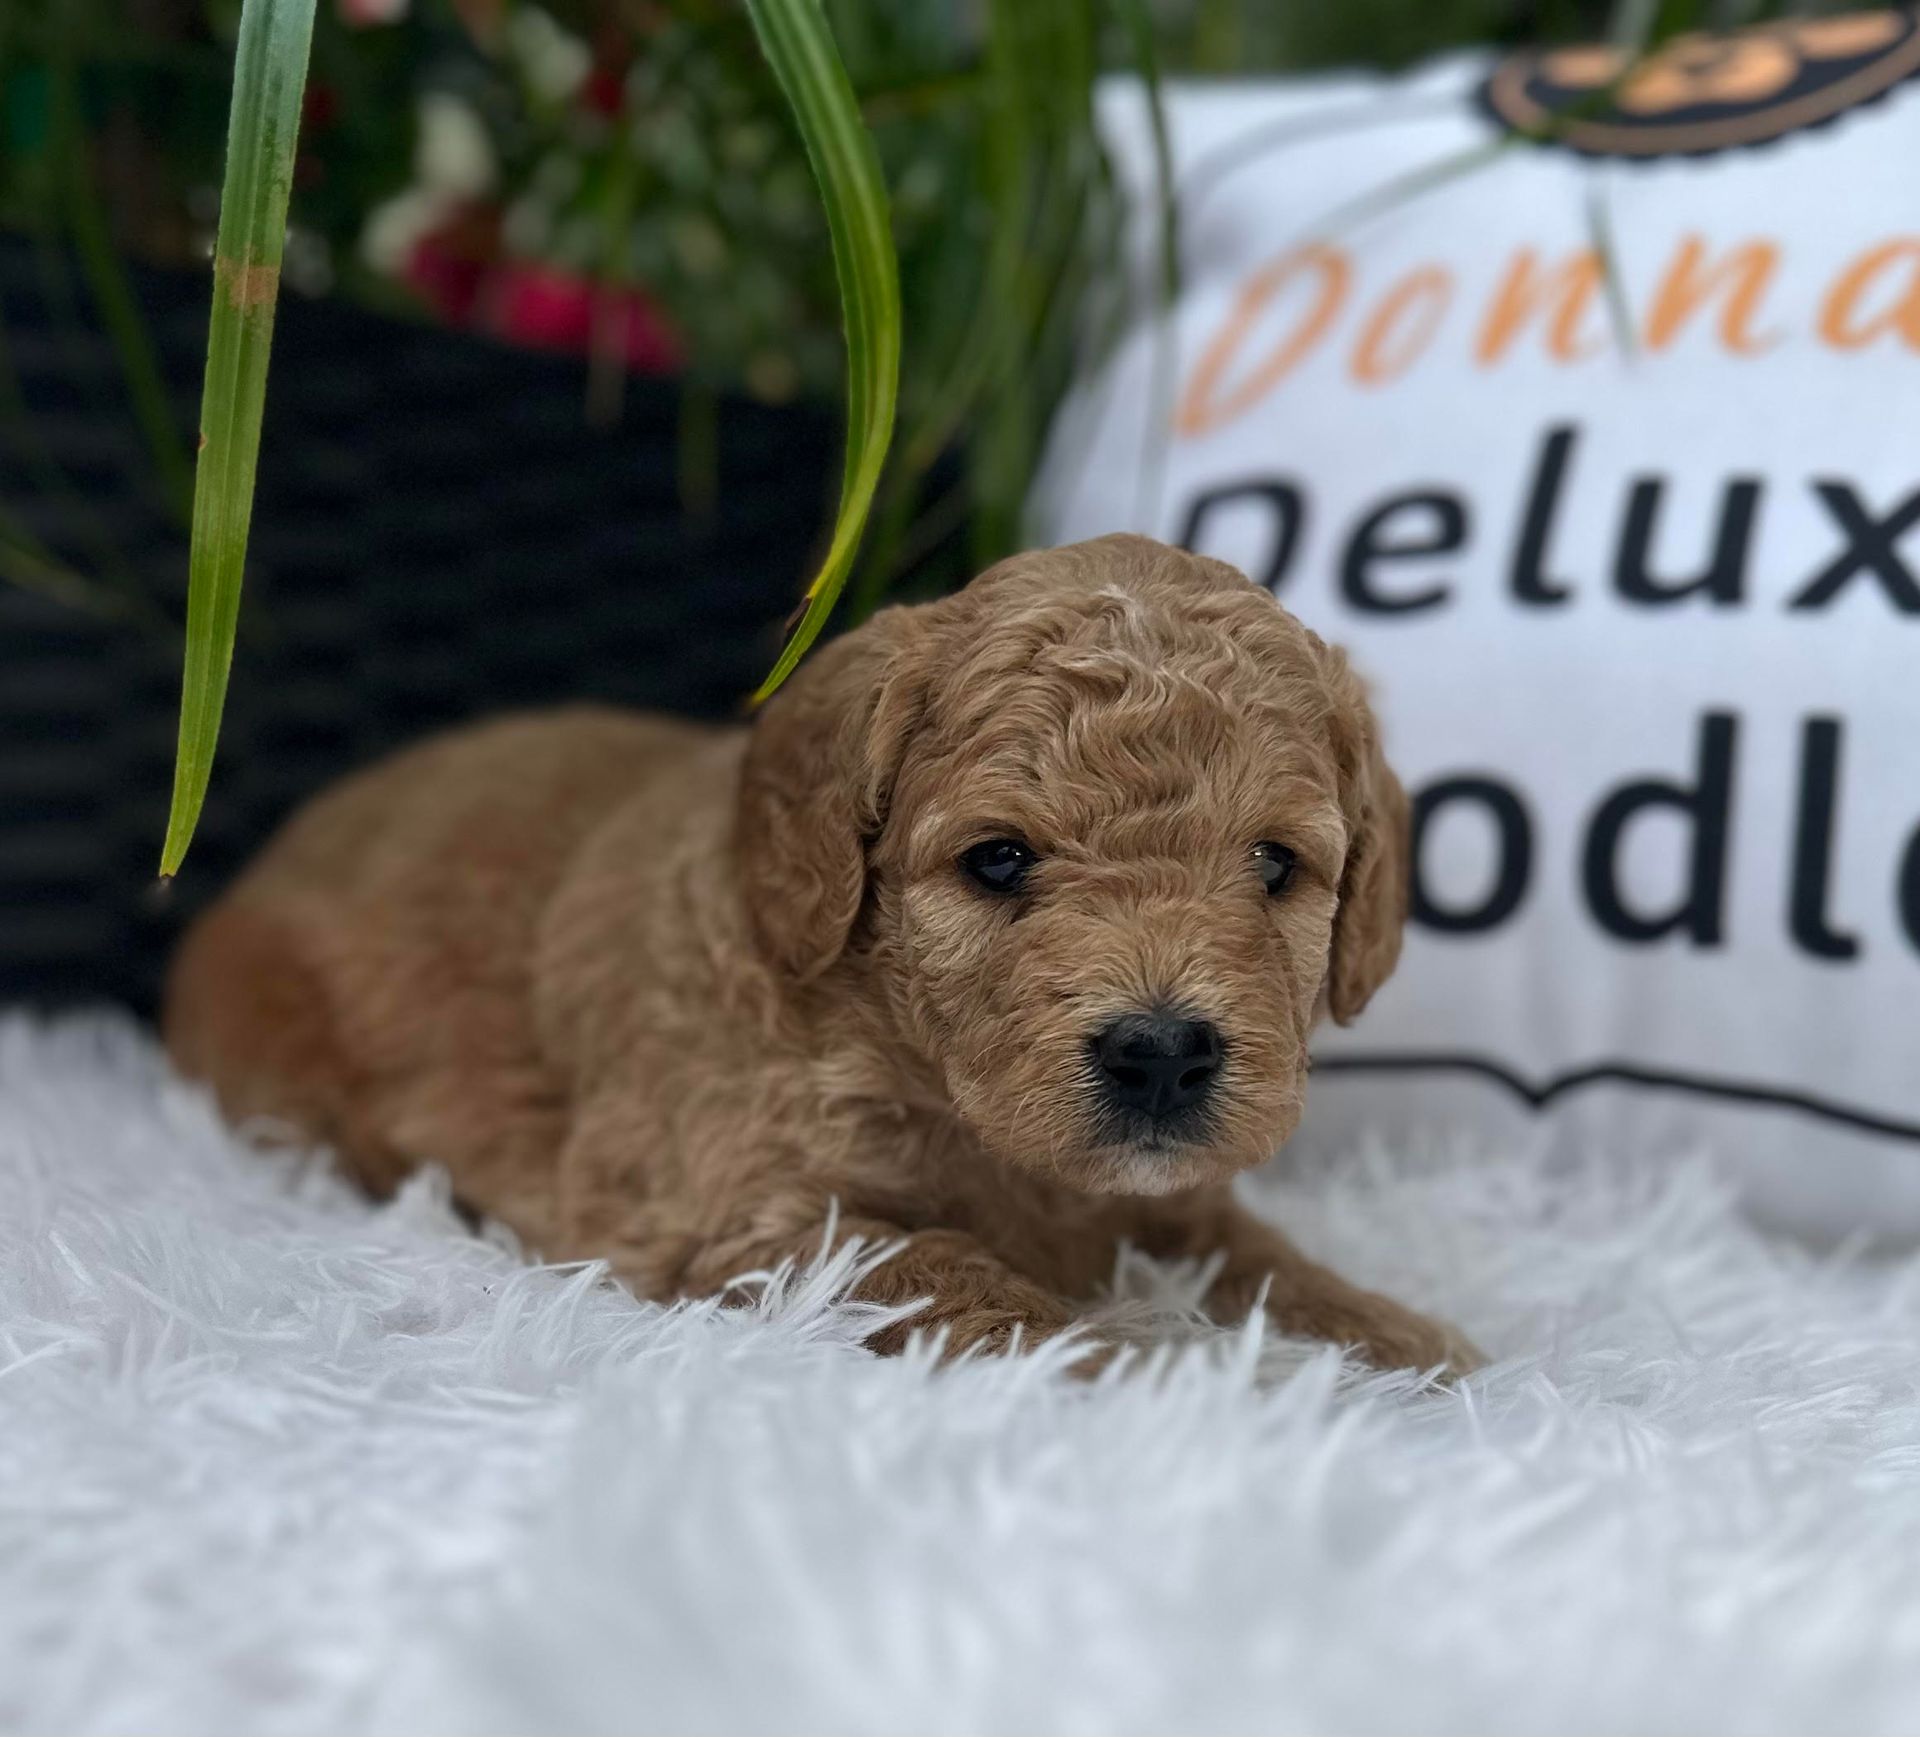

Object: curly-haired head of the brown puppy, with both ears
[735,537,1407,1194]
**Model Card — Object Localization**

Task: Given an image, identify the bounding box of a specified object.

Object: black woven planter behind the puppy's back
[0,240,839,1011]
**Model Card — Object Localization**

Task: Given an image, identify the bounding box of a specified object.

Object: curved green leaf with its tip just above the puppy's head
[747,0,900,704]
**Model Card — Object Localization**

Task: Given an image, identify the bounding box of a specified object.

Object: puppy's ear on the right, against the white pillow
[1327,651,1411,1025]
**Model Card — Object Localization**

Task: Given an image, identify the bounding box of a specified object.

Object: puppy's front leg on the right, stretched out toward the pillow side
[1194,1203,1486,1374]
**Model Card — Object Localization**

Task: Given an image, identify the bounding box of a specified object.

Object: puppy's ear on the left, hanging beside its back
[733,608,924,977]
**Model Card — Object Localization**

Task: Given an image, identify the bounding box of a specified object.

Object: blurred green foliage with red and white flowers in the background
[0,0,1889,607]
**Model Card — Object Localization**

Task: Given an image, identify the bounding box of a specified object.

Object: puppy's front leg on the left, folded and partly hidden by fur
[687,1217,1075,1357]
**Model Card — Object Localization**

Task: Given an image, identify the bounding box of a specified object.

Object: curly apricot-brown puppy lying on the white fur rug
[167,537,1473,1368]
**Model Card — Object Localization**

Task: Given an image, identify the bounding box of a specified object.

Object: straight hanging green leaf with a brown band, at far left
[159,0,315,875]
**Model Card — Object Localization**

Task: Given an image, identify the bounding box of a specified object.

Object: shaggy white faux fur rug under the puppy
[0,1019,1920,1733]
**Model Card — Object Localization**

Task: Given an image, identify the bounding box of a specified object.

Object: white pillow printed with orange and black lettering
[1035,13,1920,1238]
